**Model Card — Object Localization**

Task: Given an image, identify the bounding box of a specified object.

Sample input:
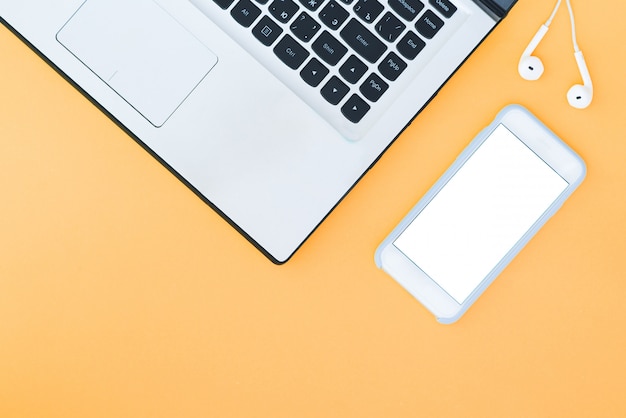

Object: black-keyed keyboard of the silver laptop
[194,0,457,139]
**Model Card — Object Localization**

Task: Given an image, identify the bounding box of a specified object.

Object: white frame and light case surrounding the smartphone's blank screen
[375,105,586,323]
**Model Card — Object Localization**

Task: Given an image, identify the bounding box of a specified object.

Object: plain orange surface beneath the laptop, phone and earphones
[0,0,626,418]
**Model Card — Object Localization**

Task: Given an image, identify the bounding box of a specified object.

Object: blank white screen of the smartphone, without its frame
[394,124,568,304]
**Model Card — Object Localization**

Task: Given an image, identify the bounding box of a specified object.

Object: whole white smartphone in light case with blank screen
[375,105,586,323]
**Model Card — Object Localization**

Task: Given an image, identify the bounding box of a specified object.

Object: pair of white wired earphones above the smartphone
[517,0,593,109]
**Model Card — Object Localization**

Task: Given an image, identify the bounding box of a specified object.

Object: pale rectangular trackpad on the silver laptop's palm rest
[57,0,217,127]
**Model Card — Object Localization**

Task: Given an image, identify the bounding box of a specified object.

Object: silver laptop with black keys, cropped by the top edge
[0,0,516,263]
